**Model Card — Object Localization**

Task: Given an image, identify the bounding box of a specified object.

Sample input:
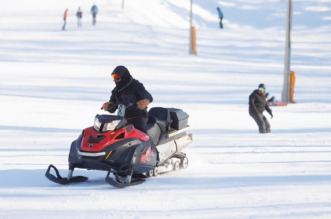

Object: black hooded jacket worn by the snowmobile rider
[108,66,153,119]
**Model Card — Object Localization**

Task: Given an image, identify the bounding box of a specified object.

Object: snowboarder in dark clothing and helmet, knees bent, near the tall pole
[248,84,273,133]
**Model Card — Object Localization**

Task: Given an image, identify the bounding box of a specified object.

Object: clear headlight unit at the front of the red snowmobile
[94,115,126,132]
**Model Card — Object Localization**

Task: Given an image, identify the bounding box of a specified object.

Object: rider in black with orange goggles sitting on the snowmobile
[102,66,153,133]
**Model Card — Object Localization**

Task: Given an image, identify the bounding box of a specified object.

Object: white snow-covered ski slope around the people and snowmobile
[0,0,331,219]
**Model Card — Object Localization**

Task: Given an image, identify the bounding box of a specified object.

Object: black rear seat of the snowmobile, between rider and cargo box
[148,107,171,132]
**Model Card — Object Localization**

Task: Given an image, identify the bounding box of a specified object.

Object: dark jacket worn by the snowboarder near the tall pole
[248,90,272,115]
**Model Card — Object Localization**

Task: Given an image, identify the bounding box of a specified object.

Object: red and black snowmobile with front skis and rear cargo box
[45,104,192,188]
